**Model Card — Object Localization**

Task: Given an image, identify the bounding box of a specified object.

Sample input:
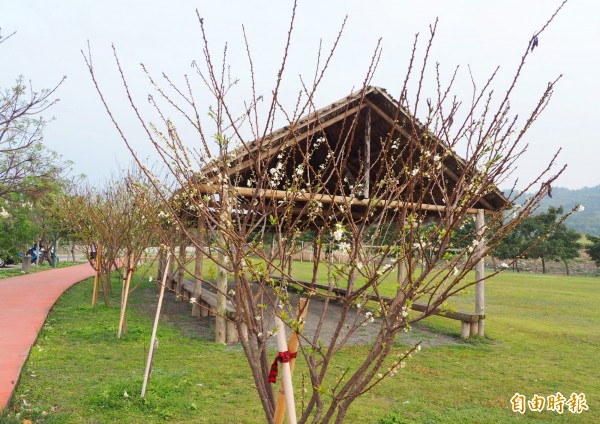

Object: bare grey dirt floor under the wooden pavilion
[131,288,461,347]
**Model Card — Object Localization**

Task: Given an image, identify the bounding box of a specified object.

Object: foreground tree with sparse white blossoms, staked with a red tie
[86,2,572,422]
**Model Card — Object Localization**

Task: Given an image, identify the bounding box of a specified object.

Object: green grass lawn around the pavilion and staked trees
[0,264,600,423]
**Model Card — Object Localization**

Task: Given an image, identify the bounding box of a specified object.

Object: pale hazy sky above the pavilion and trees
[0,0,600,189]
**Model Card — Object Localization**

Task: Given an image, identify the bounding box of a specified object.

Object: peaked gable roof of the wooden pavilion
[203,87,508,219]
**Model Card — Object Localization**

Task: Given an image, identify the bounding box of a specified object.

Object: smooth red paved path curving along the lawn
[0,263,94,411]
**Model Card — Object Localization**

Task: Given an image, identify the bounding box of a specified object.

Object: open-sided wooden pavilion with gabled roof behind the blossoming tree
[166,87,508,337]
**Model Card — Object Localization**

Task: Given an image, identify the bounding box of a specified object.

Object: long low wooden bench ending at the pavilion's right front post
[271,275,485,339]
